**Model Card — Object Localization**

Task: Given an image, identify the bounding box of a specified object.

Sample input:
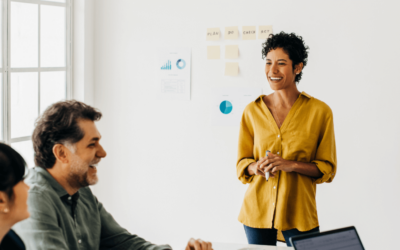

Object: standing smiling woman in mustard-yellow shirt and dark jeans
[236,32,337,246]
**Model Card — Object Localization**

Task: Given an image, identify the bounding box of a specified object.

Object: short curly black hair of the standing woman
[262,31,310,83]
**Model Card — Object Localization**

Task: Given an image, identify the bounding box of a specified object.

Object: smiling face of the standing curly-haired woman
[265,48,303,90]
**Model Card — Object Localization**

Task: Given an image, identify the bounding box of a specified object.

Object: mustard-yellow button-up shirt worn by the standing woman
[236,92,337,240]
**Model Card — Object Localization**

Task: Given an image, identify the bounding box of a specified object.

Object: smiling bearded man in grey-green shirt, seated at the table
[13,101,212,250]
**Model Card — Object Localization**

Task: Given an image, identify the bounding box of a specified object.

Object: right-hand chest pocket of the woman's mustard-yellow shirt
[288,131,318,162]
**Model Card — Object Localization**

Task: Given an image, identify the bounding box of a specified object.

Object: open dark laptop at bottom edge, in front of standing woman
[290,227,365,250]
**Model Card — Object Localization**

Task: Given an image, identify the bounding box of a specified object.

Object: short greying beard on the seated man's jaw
[67,154,98,188]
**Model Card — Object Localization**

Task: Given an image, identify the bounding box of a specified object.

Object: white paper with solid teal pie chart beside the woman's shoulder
[210,88,262,126]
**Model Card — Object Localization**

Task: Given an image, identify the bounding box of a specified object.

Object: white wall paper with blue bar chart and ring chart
[156,48,191,100]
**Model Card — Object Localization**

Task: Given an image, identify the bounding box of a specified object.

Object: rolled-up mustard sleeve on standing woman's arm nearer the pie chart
[236,110,256,184]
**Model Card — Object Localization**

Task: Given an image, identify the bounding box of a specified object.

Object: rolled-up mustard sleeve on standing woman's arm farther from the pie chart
[312,112,337,184]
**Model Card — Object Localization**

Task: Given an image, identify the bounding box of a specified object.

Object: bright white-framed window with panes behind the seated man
[0,0,71,167]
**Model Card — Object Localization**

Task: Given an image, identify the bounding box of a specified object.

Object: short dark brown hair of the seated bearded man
[32,100,102,168]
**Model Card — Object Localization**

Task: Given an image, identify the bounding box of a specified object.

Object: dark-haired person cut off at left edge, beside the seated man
[0,143,29,250]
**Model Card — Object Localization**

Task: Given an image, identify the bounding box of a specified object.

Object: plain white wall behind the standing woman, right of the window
[90,0,400,249]
